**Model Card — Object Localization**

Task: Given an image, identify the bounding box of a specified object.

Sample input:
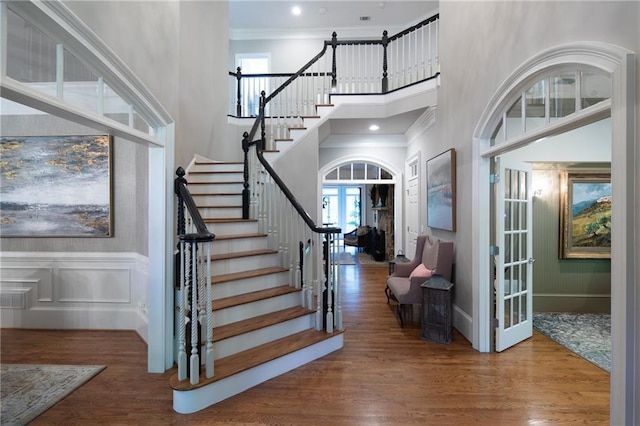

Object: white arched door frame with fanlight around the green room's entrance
[472,42,640,424]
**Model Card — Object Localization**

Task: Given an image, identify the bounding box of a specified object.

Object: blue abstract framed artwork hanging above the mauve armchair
[427,148,456,231]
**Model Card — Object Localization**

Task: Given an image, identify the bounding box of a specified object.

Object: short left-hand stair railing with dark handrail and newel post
[174,167,215,385]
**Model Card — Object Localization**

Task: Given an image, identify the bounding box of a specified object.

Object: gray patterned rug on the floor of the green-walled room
[533,312,611,373]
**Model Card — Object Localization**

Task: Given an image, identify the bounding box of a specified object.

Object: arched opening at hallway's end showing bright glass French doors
[321,160,397,262]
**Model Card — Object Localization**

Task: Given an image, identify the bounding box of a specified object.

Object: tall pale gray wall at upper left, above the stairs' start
[65,1,231,167]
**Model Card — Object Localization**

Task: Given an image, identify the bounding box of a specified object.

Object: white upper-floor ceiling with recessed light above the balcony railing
[229,0,438,39]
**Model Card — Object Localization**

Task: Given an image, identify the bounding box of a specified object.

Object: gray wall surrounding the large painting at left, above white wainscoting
[0,114,148,255]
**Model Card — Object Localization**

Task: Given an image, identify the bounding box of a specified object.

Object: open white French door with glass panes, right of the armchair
[494,158,534,352]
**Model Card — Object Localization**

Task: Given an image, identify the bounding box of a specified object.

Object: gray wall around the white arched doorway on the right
[420,2,640,314]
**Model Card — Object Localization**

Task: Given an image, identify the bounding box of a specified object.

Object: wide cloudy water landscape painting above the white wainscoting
[0,135,112,237]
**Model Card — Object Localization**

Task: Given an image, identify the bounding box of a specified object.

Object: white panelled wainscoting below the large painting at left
[0,252,148,341]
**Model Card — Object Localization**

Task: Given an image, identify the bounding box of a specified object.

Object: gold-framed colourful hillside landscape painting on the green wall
[560,172,611,259]
